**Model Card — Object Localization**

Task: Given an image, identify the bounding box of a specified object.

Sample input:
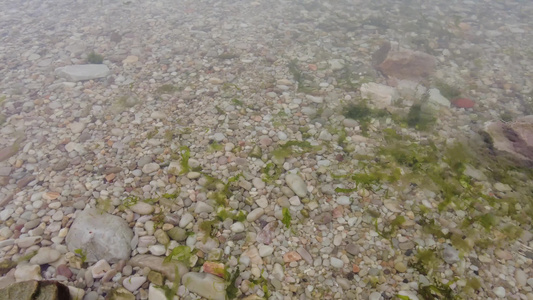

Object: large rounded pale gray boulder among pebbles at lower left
[66,208,133,263]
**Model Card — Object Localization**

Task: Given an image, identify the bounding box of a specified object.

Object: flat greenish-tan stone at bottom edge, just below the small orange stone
[182,272,226,300]
